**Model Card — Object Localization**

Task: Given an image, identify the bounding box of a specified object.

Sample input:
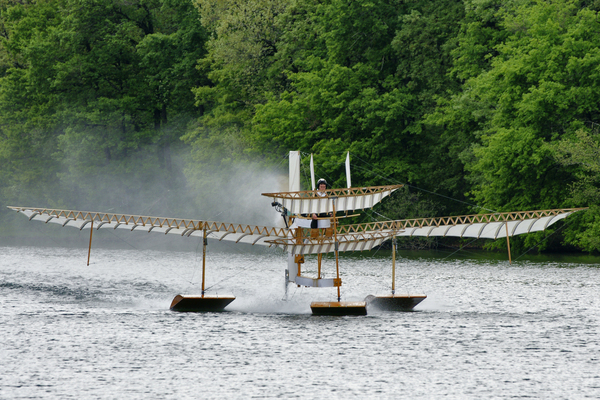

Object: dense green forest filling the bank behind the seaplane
[0,0,600,253]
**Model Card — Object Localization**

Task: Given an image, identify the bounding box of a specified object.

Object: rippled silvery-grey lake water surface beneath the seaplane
[0,247,600,399]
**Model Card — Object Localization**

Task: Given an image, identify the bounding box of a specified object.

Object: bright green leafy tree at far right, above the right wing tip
[436,1,600,209]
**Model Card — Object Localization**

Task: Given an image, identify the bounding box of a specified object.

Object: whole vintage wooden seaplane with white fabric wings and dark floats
[8,151,586,315]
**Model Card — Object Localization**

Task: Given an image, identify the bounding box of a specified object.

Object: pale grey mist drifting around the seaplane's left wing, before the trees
[0,138,288,248]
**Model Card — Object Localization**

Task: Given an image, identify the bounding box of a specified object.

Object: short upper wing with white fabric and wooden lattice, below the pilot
[262,185,403,214]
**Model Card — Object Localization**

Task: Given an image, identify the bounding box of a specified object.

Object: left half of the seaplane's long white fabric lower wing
[8,207,288,246]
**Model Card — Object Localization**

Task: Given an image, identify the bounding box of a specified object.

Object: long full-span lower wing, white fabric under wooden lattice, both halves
[8,207,586,254]
